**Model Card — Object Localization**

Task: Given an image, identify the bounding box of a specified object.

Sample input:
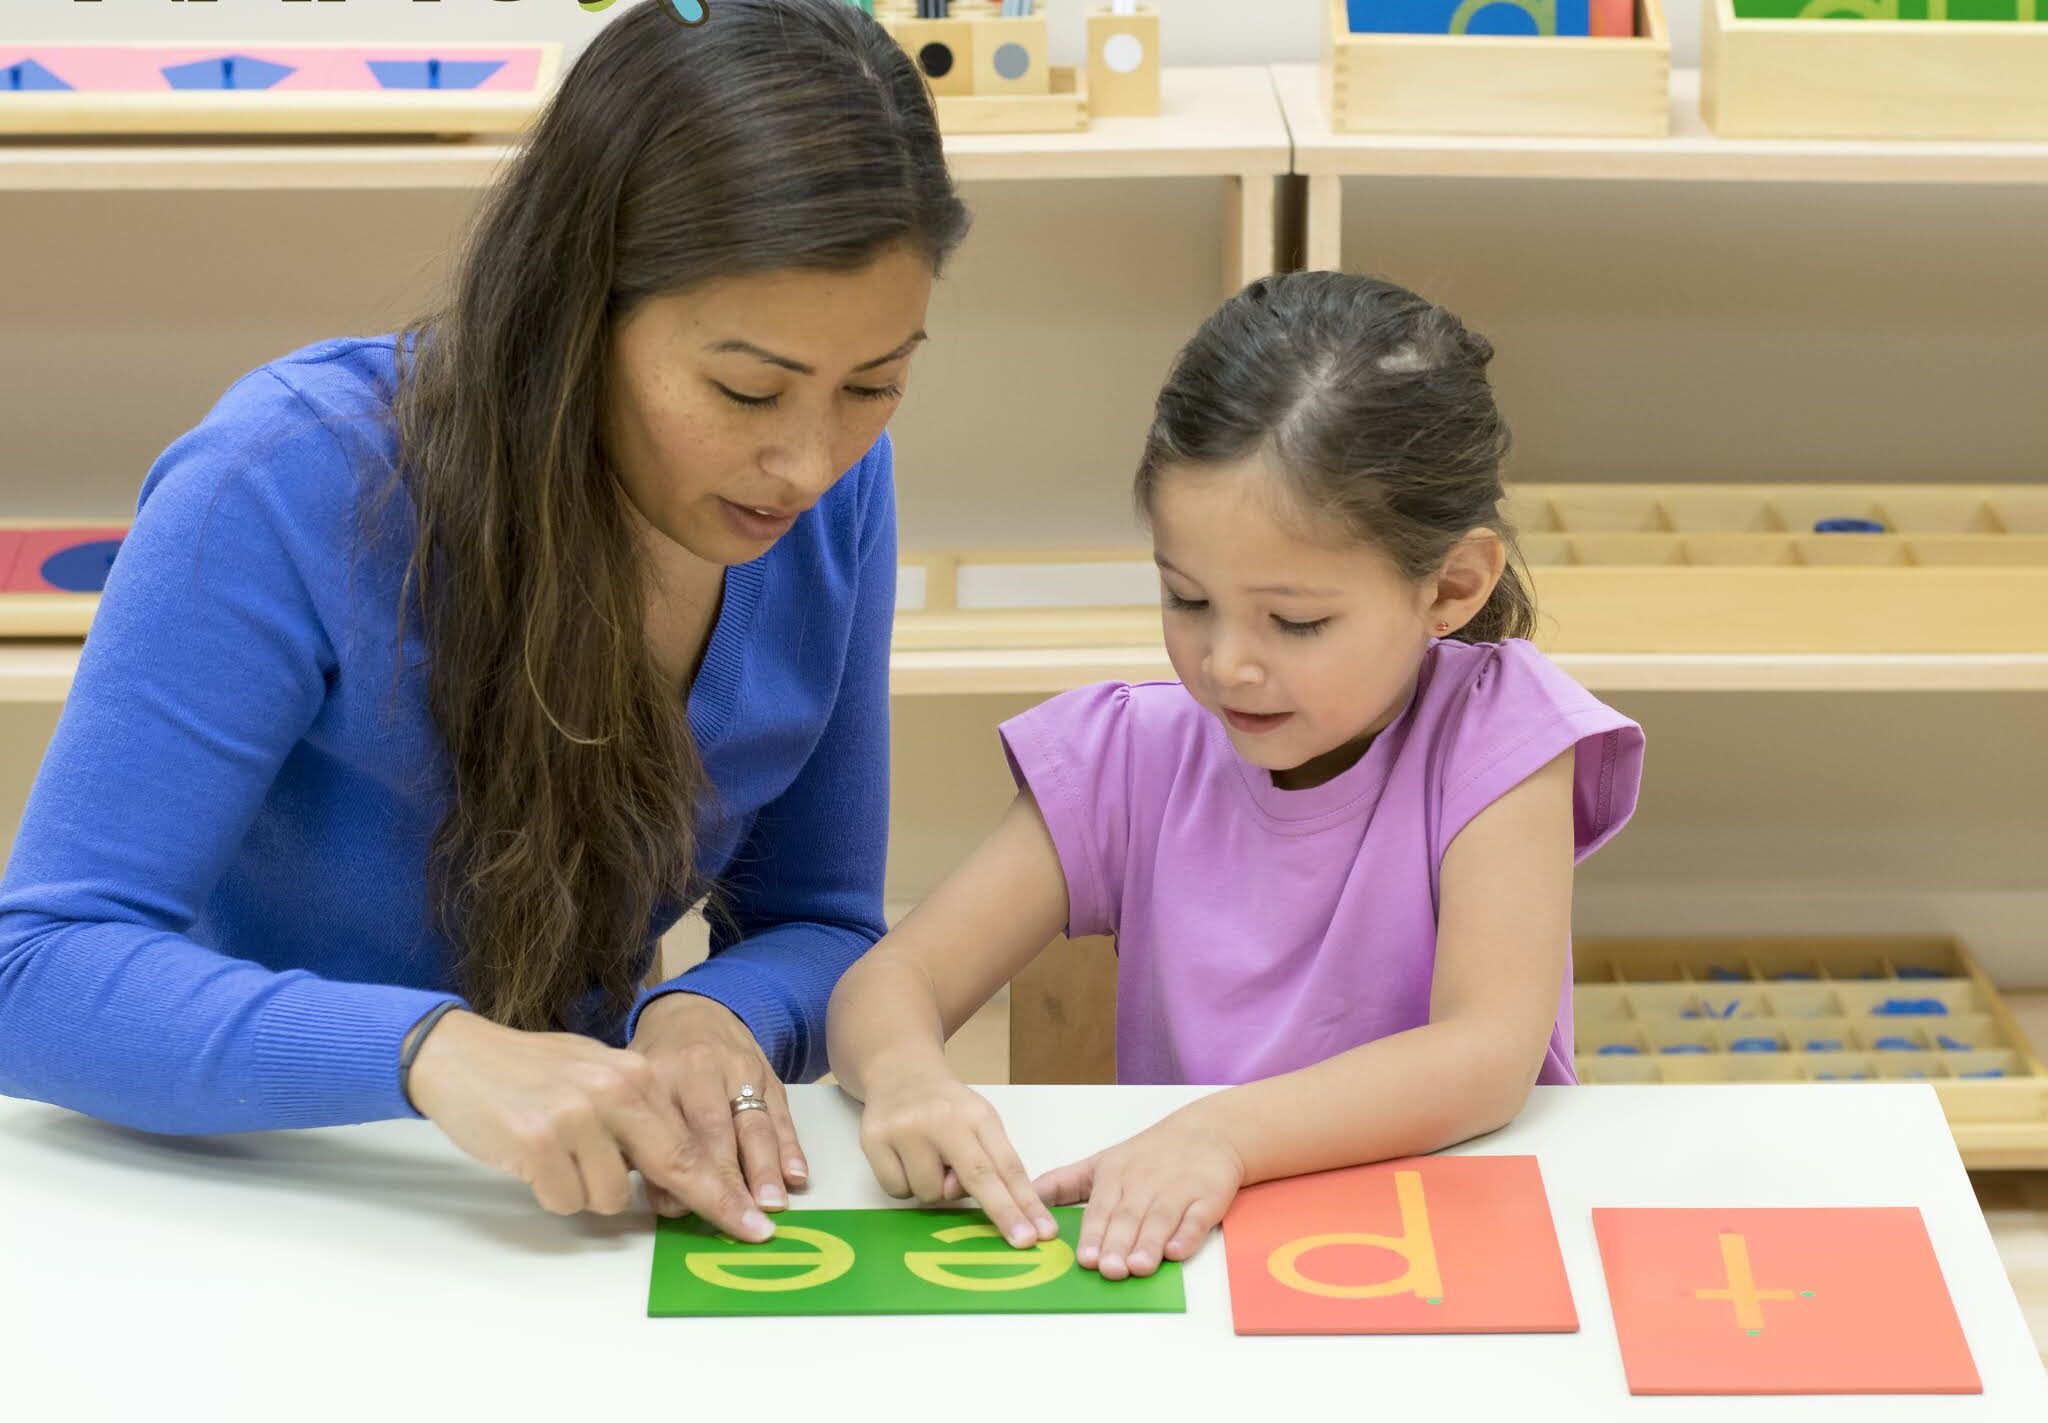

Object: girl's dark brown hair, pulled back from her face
[1137,272,1536,643]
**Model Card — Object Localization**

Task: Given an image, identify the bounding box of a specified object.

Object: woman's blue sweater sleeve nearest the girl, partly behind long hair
[629,438,897,1081]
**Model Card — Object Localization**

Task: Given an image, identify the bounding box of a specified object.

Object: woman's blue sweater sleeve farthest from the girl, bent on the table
[0,371,449,1132]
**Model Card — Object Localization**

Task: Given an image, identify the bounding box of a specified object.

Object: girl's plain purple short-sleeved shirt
[1001,641,1642,1083]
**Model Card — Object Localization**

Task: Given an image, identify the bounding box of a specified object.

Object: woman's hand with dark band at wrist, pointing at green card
[408,1003,774,1241]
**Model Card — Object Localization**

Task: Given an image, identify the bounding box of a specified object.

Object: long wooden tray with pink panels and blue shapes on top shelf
[0,41,561,137]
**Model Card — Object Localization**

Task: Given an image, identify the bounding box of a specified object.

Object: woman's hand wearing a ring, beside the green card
[627,993,811,1216]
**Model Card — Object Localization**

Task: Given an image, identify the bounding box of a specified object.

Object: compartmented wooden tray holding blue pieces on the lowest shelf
[1573,938,2048,1167]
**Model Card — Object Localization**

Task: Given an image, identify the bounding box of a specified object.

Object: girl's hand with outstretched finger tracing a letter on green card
[860,1059,1059,1249]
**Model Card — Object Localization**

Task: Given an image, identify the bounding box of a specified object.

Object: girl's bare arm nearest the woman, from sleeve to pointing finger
[827,792,1067,1247]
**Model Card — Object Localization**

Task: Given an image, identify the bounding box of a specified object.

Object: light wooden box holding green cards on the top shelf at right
[1700,0,2048,139]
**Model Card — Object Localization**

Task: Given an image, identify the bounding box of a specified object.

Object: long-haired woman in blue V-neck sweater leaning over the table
[0,0,967,1239]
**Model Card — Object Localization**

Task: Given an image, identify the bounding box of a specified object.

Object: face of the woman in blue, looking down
[604,246,932,565]
